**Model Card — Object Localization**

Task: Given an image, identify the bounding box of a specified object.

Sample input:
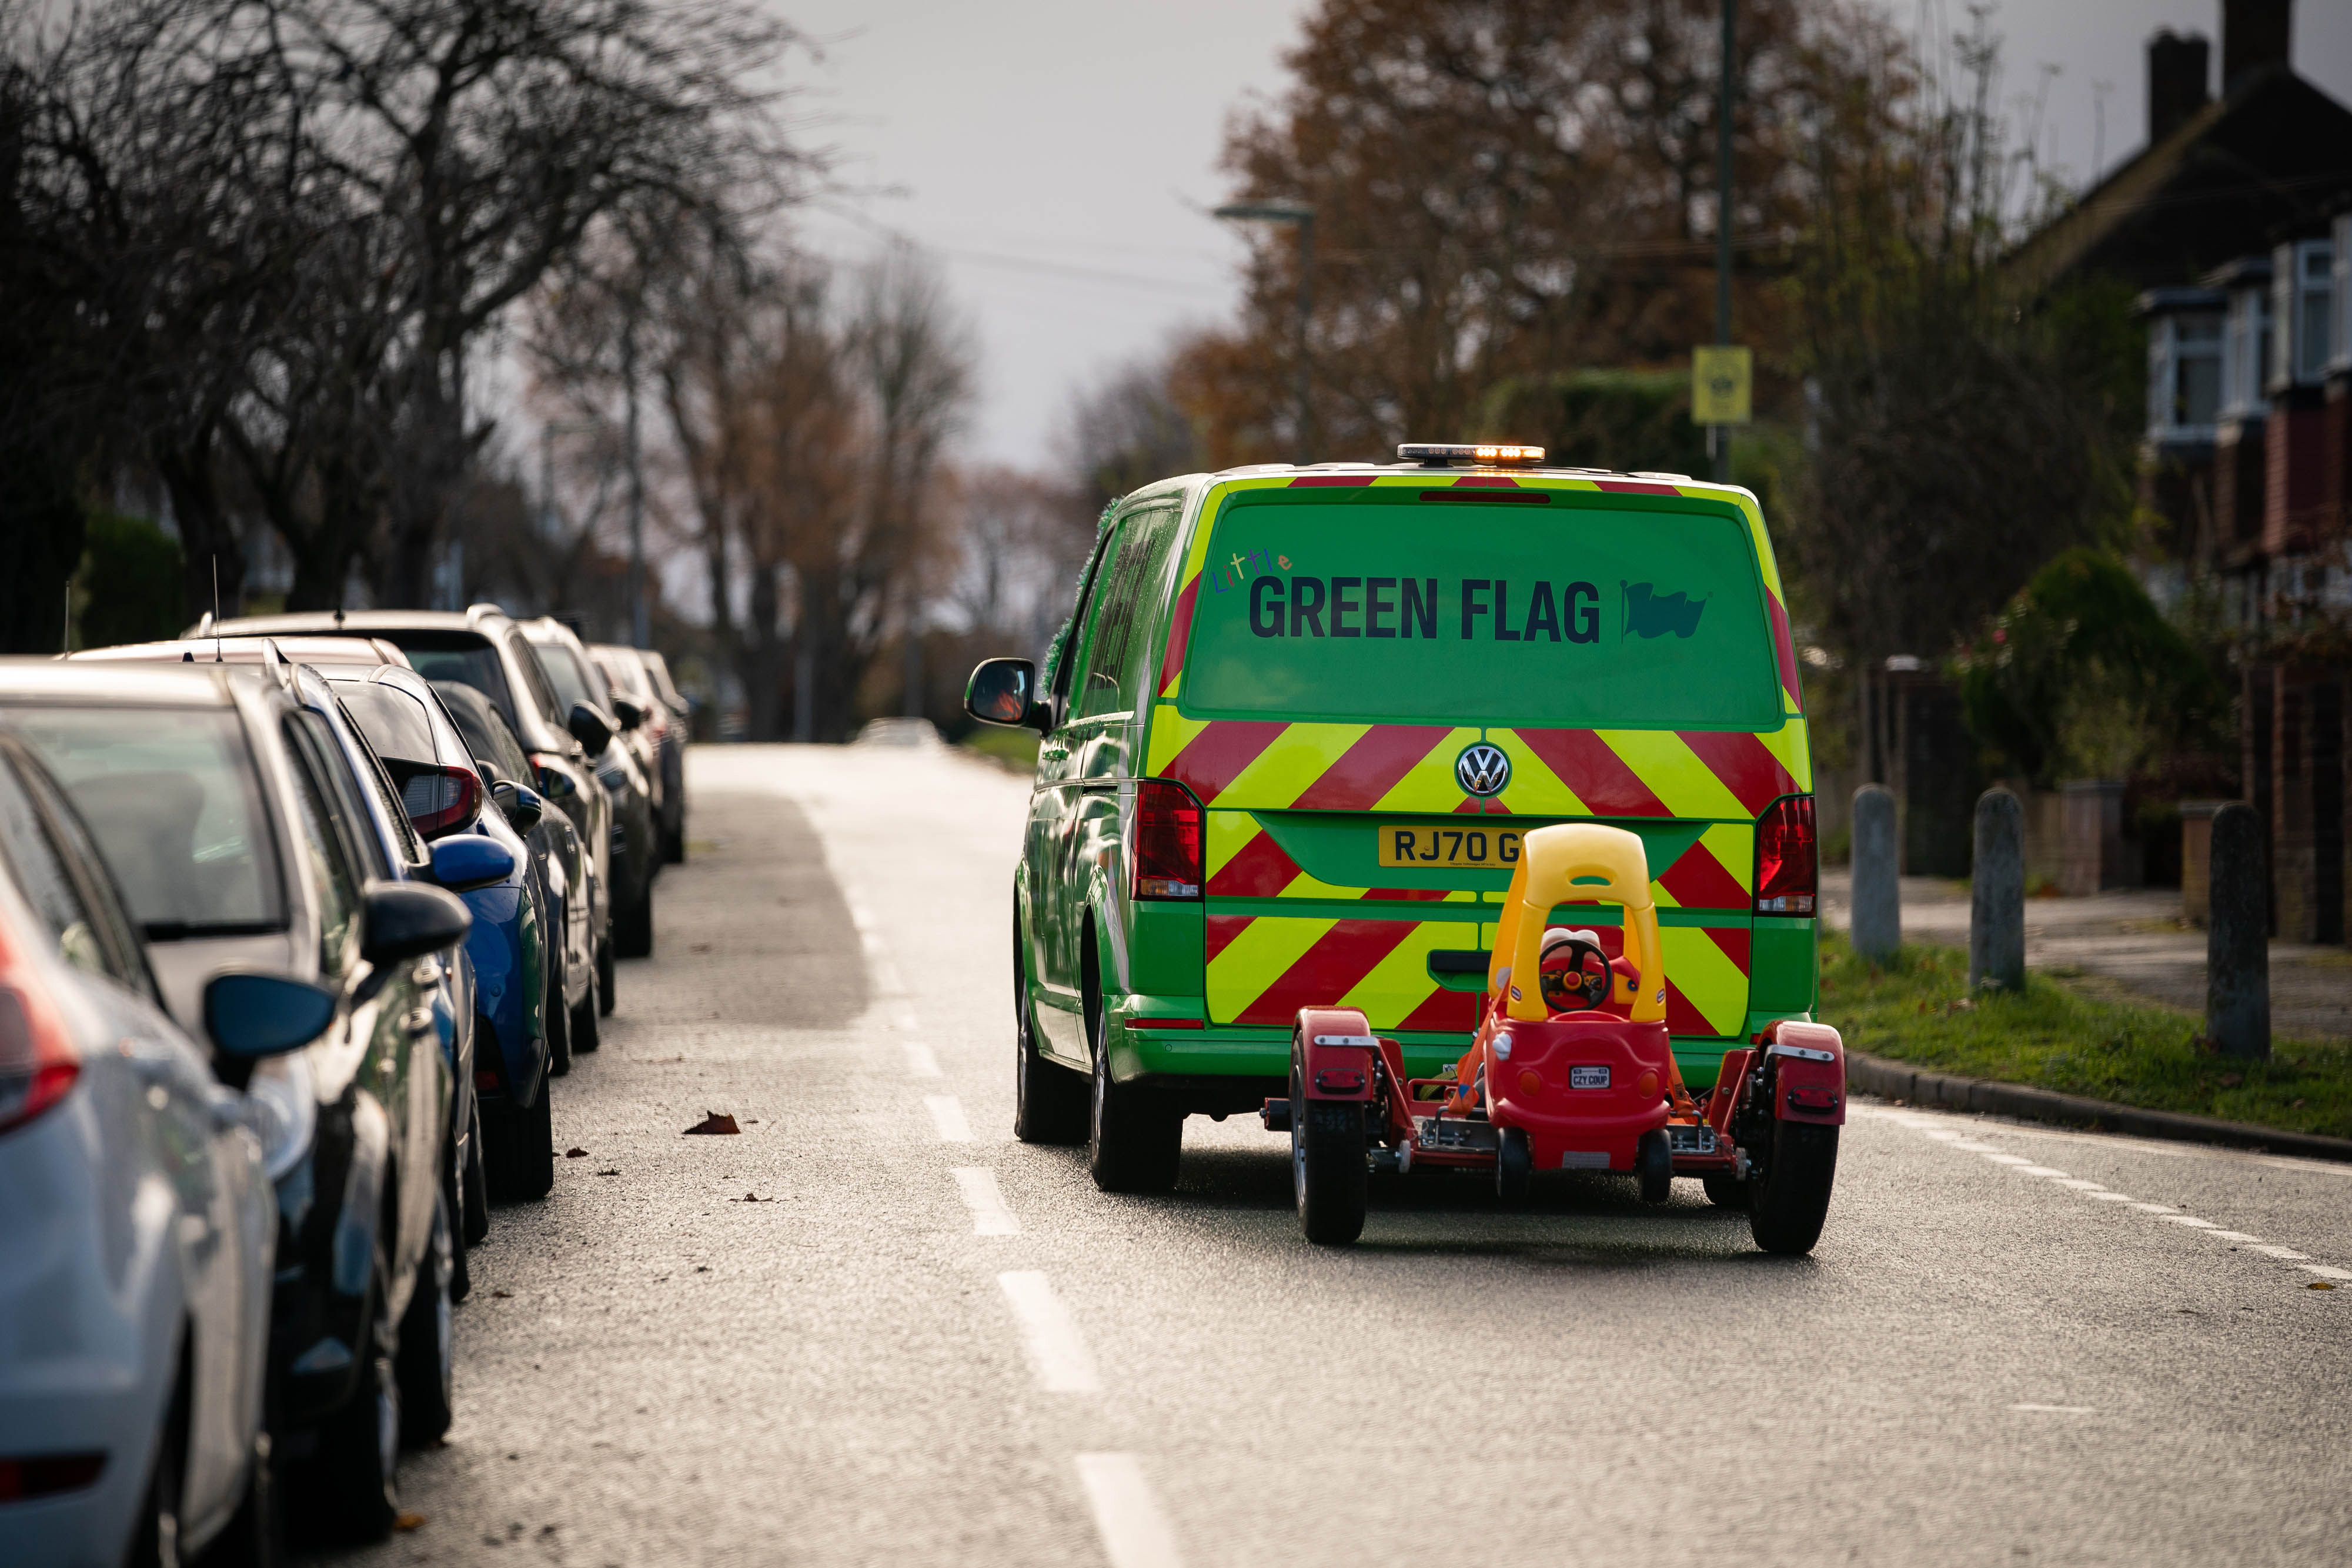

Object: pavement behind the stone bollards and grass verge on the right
[1820,867,2352,1041]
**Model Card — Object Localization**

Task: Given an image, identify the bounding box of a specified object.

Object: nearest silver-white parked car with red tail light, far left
[0,736,289,1568]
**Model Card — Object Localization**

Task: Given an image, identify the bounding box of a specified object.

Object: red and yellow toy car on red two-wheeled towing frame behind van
[1263,823,1846,1253]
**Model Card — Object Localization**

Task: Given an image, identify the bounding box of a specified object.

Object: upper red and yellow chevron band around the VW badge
[1145,703,1813,823]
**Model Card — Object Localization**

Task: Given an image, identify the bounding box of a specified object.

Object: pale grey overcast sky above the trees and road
[776,0,2352,466]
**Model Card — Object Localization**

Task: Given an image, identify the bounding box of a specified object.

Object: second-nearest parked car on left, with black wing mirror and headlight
[0,661,496,1537]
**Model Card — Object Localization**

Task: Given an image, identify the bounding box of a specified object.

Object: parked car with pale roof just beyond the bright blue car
[188,604,619,1013]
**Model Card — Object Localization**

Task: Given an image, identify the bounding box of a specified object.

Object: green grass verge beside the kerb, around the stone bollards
[1820,931,2352,1138]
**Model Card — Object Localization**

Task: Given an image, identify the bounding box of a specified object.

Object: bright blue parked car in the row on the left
[325,666,572,1203]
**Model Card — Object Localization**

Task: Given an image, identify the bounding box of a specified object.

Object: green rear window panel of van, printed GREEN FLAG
[1183,489,1783,729]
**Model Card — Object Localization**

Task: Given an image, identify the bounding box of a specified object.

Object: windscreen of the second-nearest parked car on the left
[7,706,285,940]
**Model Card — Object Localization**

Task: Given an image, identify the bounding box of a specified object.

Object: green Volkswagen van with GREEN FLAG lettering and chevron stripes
[964,447,1816,1192]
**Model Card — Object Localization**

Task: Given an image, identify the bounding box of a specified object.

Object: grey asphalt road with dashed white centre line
[322,748,2352,1568]
